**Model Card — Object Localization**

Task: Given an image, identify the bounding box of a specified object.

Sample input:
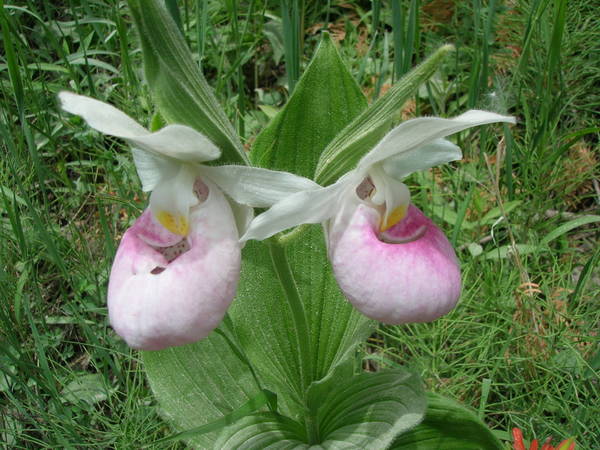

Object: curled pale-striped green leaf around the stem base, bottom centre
[215,370,426,450]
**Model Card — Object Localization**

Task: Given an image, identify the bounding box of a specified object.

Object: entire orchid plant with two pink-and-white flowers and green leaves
[60,0,514,449]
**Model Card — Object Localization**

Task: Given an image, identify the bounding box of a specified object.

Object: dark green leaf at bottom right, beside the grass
[390,393,504,450]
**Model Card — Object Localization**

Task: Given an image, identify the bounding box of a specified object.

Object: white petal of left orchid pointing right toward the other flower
[200,166,320,208]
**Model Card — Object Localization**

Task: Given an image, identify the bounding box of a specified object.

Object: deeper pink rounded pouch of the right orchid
[329,204,461,324]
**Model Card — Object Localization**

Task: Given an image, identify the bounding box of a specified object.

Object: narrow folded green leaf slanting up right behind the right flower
[314,45,454,186]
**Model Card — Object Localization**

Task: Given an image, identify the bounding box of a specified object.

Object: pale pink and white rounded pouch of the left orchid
[108,183,240,350]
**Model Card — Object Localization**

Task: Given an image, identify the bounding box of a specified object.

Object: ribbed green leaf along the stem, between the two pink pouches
[230,237,374,421]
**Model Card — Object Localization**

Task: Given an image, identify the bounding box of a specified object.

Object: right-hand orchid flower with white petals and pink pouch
[242,110,514,324]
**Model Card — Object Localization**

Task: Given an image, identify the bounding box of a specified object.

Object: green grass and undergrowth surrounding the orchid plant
[0,0,600,449]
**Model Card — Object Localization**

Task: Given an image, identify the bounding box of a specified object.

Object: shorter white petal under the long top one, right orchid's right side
[382,139,462,180]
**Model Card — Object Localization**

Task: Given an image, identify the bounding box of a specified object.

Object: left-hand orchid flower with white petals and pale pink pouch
[59,92,318,350]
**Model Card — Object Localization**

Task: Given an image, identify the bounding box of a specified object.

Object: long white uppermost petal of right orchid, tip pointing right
[358,110,515,171]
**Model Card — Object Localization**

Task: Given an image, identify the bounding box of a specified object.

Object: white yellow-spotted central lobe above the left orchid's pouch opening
[150,165,199,236]
